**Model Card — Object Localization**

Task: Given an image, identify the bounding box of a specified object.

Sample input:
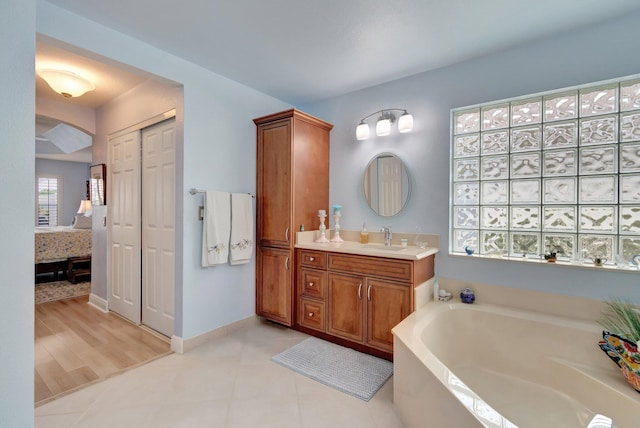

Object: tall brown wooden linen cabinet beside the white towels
[253,109,333,327]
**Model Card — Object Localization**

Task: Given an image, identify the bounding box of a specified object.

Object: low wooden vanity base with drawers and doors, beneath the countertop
[297,249,434,358]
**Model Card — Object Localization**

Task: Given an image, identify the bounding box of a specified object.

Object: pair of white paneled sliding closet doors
[109,119,176,337]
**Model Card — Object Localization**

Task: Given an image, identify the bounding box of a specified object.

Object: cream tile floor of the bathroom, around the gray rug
[35,321,403,428]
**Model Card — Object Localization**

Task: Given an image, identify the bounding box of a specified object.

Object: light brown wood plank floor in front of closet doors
[35,296,170,406]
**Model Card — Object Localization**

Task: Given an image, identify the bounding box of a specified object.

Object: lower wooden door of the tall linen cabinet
[256,247,293,326]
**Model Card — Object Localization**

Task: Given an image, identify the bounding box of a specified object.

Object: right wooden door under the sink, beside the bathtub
[366,279,411,352]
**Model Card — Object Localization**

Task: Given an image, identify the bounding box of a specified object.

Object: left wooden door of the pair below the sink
[327,273,365,343]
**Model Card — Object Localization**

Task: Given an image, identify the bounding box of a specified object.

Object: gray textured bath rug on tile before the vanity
[272,337,393,401]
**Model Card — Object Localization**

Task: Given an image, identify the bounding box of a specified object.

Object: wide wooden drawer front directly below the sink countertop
[328,254,413,285]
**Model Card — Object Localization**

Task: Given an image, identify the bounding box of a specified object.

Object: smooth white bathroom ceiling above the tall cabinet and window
[42,0,640,105]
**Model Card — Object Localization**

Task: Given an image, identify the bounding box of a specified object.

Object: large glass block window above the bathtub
[450,76,640,264]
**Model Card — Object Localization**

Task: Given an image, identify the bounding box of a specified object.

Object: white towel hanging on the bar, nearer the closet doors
[202,192,231,267]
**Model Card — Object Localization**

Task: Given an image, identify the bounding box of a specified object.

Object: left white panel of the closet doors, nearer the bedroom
[108,131,141,324]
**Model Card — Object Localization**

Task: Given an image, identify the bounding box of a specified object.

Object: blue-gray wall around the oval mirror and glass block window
[301,13,640,300]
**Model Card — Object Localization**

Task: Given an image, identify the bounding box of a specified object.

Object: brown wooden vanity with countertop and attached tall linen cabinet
[254,109,437,359]
